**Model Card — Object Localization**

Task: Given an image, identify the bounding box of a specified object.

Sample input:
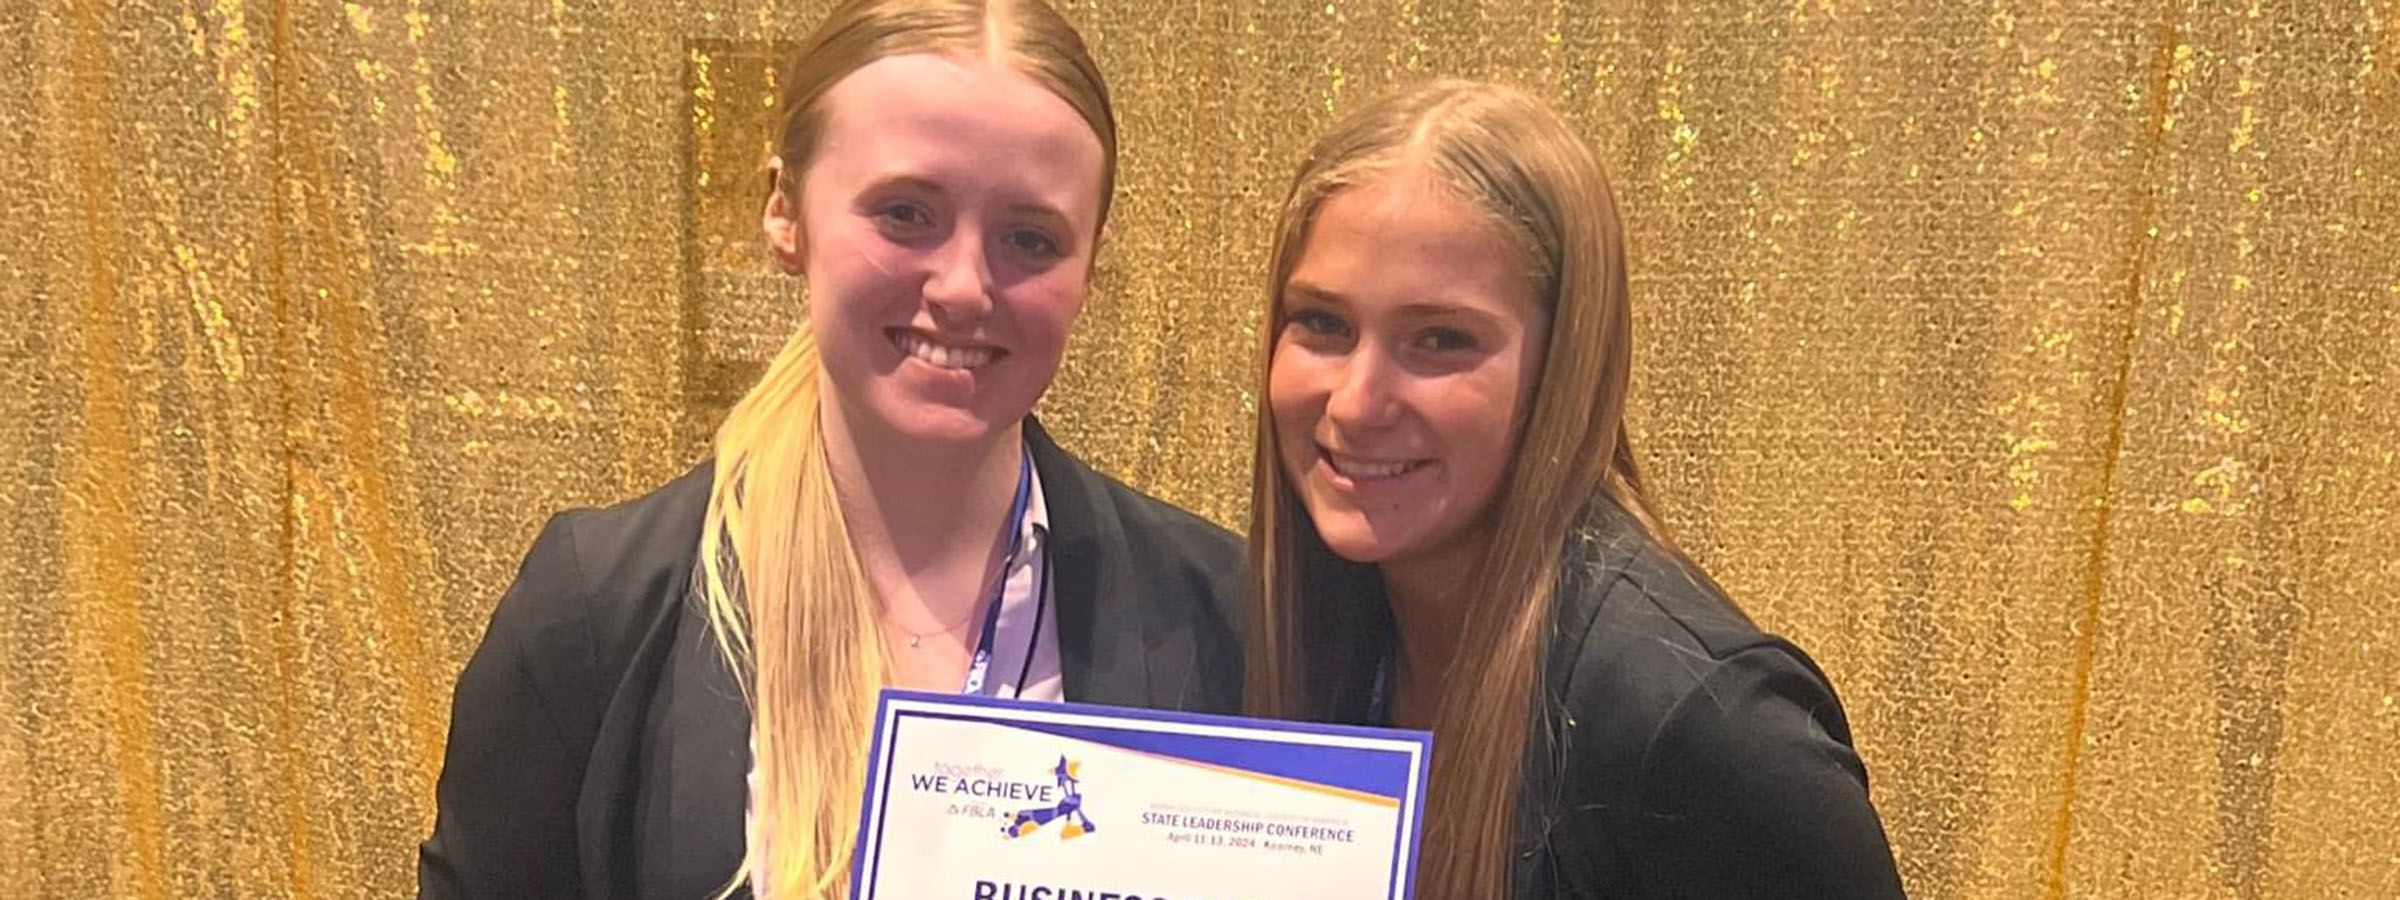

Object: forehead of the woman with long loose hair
[1291,166,1538,312]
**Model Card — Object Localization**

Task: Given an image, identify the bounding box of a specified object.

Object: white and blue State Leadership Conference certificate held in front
[850,691,1433,900]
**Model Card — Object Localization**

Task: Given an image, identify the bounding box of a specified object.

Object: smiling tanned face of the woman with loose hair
[1267,166,1548,564]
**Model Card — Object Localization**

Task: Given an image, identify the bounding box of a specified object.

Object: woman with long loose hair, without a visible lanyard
[1248,82,1901,900]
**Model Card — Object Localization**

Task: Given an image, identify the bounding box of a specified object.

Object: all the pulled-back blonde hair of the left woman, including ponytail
[696,0,1116,900]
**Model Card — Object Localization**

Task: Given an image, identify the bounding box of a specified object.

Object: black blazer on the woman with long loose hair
[1497,504,1903,900]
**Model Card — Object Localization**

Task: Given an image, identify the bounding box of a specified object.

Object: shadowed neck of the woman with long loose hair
[1378,542,1483,727]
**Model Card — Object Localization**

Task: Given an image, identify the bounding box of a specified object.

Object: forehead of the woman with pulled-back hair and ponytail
[811,53,1106,204]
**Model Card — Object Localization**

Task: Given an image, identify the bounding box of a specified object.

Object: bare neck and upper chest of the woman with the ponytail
[826,391,1025,624]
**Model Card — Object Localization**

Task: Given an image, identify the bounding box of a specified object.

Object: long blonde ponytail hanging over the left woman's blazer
[701,329,888,900]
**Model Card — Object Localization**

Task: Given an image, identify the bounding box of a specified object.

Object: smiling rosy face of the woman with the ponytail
[766,55,1106,442]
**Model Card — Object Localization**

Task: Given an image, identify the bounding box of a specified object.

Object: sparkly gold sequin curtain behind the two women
[0,0,2400,900]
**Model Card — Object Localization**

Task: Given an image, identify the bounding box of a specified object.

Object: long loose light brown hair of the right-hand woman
[1246,79,1663,900]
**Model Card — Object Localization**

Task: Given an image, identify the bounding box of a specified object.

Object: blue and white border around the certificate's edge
[850,689,1433,900]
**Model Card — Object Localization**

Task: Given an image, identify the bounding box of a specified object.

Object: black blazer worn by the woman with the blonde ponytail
[418,420,1241,900]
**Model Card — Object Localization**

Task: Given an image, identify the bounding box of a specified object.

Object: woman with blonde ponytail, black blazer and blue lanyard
[418,0,1241,900]
